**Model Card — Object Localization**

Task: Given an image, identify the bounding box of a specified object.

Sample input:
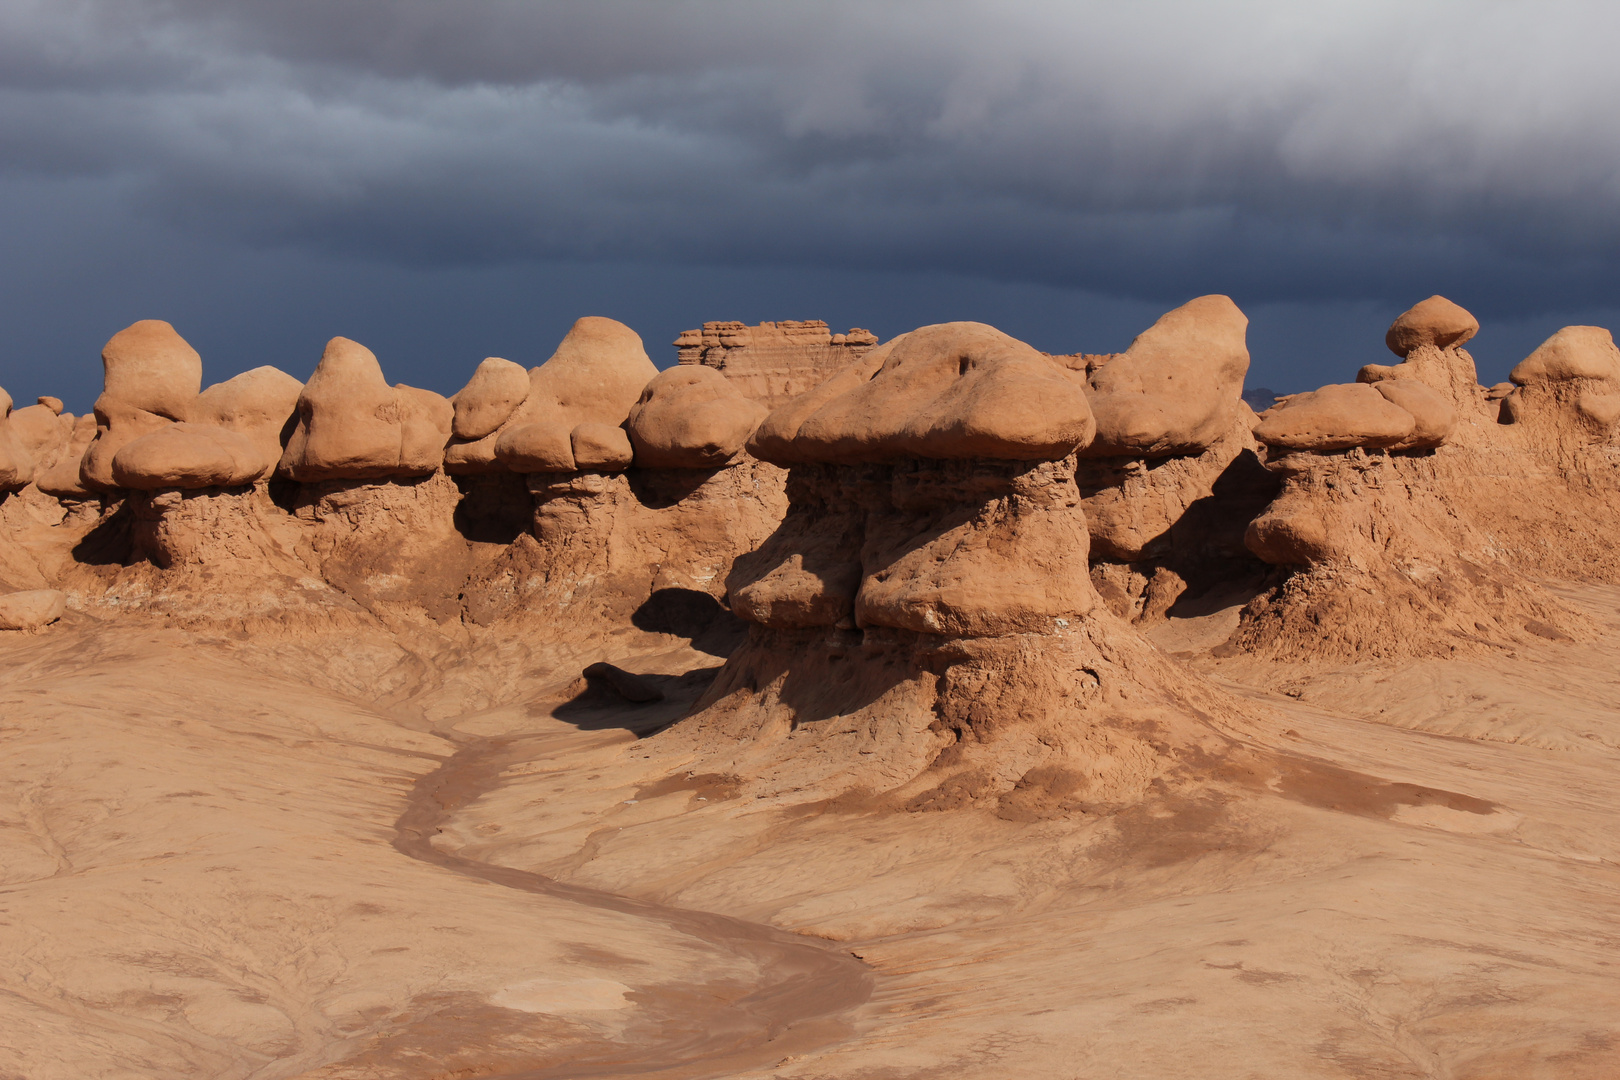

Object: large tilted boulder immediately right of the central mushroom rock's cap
[1084,296,1249,458]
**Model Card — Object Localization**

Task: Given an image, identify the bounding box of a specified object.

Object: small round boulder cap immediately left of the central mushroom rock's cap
[627,364,766,468]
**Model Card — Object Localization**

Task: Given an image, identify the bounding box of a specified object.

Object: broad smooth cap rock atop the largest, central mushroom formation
[752,322,1094,465]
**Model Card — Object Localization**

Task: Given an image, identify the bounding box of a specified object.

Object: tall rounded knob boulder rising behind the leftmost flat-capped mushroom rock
[79,319,203,491]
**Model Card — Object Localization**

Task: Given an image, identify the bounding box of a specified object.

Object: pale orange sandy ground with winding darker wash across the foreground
[0,588,1620,1080]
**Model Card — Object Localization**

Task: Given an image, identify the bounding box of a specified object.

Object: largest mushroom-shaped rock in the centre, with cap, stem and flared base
[677,322,1223,810]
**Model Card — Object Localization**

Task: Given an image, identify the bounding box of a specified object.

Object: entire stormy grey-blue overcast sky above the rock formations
[0,0,1620,410]
